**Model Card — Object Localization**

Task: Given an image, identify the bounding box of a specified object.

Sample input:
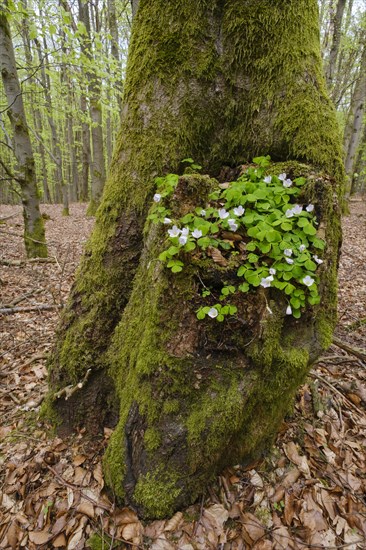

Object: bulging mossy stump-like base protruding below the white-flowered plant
[104,167,339,518]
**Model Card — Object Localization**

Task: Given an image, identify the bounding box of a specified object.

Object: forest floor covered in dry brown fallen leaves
[0,202,366,550]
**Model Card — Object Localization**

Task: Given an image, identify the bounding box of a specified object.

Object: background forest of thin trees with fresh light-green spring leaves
[0,0,366,215]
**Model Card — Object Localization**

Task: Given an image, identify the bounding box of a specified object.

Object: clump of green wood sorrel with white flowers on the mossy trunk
[149,157,325,321]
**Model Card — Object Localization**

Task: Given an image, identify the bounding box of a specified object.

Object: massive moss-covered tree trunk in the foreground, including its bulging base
[50,0,343,517]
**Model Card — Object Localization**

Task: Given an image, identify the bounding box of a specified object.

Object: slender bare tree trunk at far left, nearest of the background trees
[0,12,47,258]
